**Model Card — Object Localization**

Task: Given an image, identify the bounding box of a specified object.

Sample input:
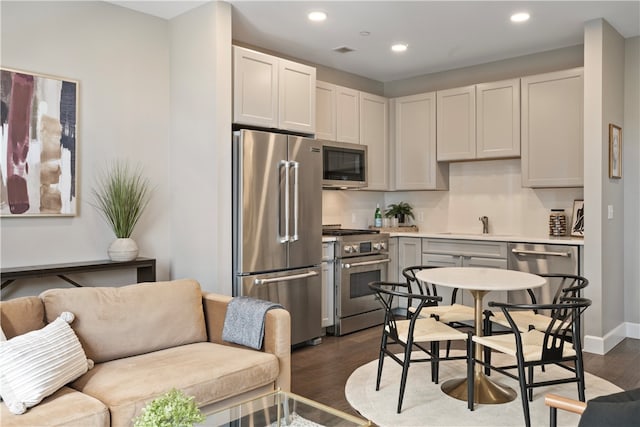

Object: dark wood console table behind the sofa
[0,258,156,289]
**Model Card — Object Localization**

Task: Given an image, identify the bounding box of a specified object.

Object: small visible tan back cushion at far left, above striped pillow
[0,297,45,339]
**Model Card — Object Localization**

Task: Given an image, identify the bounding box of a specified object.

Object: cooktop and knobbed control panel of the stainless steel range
[322,225,389,258]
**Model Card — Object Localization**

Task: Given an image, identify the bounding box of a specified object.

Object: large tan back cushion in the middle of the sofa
[40,280,207,363]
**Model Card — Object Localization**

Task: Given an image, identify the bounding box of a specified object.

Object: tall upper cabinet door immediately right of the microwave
[359,92,389,190]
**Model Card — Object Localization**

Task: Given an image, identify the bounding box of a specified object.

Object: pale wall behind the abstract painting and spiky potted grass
[0,1,170,298]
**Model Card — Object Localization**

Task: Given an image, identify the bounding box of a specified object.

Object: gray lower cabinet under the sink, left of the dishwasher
[421,239,507,308]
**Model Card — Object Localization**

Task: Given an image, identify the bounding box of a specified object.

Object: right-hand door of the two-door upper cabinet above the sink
[476,79,520,159]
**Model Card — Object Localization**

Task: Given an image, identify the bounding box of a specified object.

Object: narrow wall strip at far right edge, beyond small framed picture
[622,37,640,332]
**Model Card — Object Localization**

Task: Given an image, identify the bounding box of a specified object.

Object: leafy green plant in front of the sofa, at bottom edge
[133,388,205,427]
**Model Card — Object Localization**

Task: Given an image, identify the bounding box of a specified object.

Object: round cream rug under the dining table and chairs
[345,351,622,427]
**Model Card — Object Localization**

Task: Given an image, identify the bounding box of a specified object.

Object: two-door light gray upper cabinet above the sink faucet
[437,79,520,161]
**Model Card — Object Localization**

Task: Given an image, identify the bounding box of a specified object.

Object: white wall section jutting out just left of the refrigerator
[169,2,232,295]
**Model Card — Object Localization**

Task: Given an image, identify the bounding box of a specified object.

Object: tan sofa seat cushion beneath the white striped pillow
[0,387,110,427]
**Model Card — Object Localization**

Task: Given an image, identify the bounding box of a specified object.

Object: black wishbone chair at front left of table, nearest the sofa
[369,282,470,413]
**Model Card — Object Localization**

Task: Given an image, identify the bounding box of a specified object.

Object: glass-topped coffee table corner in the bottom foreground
[198,390,372,427]
